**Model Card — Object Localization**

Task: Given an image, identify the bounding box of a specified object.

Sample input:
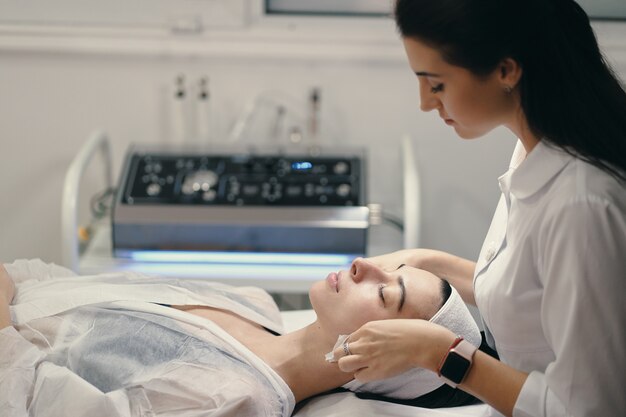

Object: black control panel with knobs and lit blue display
[120,152,365,207]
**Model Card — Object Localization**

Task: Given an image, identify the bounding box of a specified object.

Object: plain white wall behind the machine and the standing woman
[0,17,626,263]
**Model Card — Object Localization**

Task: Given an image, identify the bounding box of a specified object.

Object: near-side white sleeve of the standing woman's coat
[513,198,626,417]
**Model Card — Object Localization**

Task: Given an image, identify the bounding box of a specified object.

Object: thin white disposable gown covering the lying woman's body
[0,261,295,417]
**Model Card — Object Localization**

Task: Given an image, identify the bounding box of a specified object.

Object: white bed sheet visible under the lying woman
[281,310,501,417]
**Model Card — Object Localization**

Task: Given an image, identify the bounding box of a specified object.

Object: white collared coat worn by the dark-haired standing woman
[474,143,626,417]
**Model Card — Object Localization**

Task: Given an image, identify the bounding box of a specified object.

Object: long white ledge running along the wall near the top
[0,22,405,63]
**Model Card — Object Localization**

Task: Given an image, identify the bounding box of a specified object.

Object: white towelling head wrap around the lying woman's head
[343,288,480,399]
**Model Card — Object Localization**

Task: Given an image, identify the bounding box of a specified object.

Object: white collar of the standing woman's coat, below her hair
[510,140,573,200]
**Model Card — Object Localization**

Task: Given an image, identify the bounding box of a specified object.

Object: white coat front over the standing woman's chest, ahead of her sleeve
[474,194,553,370]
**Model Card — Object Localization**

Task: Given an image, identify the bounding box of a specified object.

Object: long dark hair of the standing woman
[395,0,626,181]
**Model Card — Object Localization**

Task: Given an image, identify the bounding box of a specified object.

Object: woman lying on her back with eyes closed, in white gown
[0,259,480,417]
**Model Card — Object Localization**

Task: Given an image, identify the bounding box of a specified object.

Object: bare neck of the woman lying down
[251,322,353,402]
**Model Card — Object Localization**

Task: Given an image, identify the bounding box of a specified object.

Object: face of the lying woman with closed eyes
[309,258,442,334]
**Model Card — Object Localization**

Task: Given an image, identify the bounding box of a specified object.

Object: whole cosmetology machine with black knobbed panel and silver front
[112,146,369,261]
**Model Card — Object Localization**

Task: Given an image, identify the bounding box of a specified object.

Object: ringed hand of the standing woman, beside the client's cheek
[334,319,455,382]
